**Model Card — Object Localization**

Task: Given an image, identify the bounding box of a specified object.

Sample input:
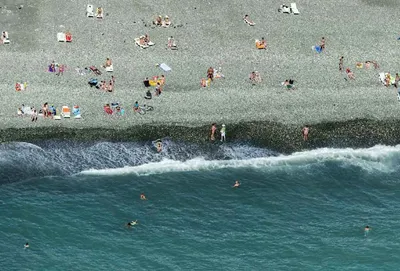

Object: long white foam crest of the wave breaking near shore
[80,145,400,175]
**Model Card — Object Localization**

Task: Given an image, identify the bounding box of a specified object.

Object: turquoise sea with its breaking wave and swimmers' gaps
[0,142,400,270]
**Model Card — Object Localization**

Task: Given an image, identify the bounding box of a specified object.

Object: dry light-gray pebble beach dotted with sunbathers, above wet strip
[0,0,400,128]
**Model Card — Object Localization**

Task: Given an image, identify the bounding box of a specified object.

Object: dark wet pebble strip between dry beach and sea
[0,119,400,154]
